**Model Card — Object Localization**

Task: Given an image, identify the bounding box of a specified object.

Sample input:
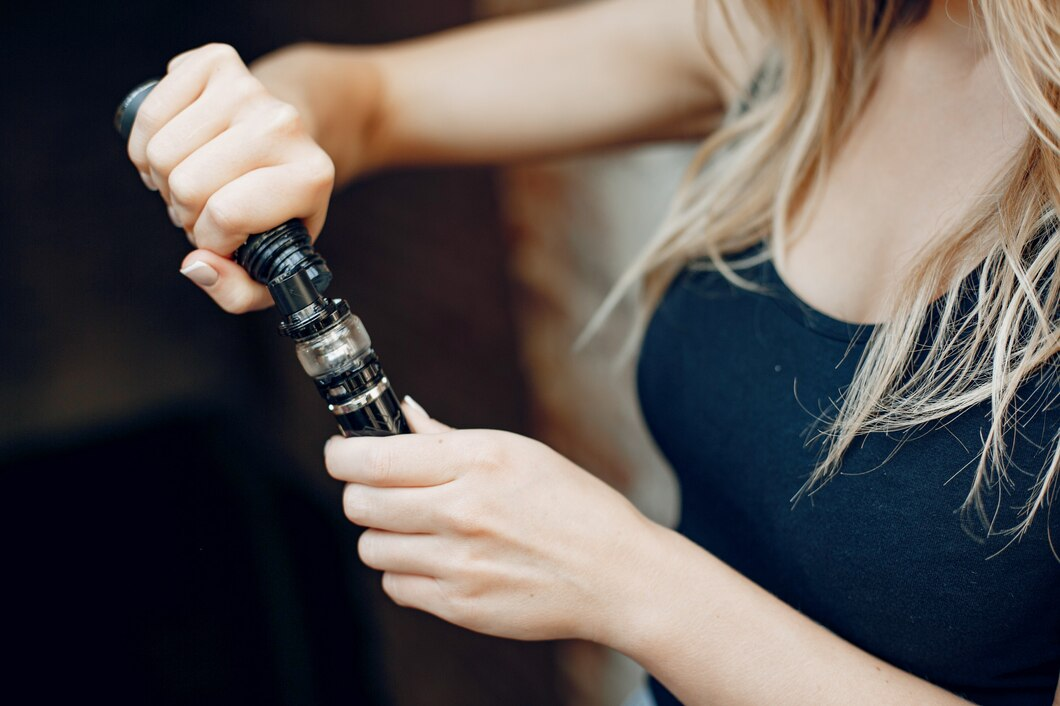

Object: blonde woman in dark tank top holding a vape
[129,0,1060,704]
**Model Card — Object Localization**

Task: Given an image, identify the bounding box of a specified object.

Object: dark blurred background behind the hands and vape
[0,0,561,705]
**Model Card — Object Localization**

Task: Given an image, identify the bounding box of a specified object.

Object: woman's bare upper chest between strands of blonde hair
[783,31,1027,321]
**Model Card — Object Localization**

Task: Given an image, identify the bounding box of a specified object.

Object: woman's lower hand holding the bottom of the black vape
[324,403,650,641]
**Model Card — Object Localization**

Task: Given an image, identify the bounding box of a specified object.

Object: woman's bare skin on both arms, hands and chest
[129,0,1060,705]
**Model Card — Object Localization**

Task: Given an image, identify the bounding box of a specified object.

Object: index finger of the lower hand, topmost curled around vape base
[324,431,469,488]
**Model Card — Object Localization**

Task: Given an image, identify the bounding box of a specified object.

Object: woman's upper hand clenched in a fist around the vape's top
[128,45,335,313]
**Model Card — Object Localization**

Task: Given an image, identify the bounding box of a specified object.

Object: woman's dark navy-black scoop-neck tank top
[637,250,1060,706]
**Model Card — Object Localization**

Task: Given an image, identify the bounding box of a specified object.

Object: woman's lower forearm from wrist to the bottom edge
[606,525,967,706]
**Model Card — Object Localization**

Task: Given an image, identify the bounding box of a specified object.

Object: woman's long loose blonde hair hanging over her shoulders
[587,0,1060,542]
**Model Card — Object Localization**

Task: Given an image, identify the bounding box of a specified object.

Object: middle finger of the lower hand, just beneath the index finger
[342,483,439,533]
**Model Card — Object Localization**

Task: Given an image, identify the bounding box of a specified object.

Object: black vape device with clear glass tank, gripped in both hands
[114,81,409,437]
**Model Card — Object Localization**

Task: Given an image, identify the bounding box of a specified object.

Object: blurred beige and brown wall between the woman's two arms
[477,0,694,706]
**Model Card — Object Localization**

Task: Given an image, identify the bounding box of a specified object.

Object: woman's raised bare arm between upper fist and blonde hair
[253,0,721,182]
